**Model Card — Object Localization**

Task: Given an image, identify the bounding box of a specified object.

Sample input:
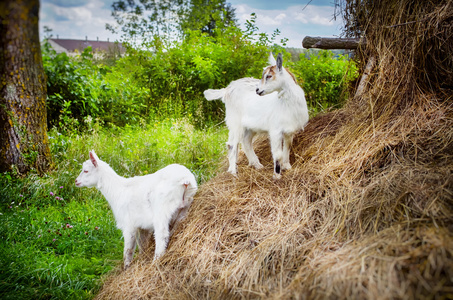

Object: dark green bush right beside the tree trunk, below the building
[43,43,149,132]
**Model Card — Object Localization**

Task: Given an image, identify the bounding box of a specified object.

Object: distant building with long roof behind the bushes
[48,38,126,56]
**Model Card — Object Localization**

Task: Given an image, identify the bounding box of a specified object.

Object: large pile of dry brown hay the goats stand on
[98,0,453,299]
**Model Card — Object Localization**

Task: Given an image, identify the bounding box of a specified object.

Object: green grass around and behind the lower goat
[0,119,227,299]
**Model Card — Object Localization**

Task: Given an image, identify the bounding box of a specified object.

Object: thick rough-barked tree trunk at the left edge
[0,0,51,175]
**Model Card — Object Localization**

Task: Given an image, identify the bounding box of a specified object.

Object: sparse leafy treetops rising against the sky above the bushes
[106,0,236,46]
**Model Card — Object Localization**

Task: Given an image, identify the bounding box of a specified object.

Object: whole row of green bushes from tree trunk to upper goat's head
[43,19,285,131]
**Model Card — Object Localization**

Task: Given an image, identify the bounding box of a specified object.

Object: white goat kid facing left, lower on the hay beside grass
[75,151,197,269]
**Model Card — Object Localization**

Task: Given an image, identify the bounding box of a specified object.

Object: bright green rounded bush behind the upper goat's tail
[125,27,278,125]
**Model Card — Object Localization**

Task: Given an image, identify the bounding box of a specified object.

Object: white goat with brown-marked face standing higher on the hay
[204,53,308,179]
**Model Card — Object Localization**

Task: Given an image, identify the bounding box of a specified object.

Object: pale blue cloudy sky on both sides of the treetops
[39,0,343,48]
